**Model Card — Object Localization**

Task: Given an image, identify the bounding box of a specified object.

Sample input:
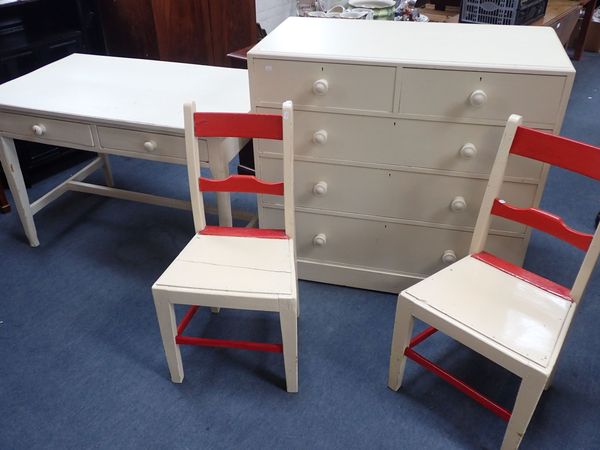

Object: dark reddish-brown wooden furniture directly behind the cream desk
[97,0,257,66]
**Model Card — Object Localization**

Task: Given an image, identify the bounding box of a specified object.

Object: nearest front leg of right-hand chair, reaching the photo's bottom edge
[501,374,546,450]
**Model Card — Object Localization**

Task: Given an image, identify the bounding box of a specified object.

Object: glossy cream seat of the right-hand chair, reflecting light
[401,256,575,368]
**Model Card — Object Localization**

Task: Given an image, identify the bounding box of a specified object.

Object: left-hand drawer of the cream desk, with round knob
[0,113,94,147]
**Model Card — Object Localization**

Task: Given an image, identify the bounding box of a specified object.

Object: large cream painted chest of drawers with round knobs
[248,18,575,292]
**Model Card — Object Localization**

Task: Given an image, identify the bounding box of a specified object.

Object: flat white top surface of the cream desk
[0,53,250,134]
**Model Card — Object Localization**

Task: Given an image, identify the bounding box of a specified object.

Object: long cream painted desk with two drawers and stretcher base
[0,54,250,247]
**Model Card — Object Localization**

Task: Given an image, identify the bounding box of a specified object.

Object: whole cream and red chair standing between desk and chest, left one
[152,101,298,392]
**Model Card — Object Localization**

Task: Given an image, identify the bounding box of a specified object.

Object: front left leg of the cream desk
[0,137,40,247]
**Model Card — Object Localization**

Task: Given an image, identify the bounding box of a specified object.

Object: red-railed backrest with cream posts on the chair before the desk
[183,101,295,239]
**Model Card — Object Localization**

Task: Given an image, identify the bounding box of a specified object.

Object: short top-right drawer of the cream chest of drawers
[400,69,566,125]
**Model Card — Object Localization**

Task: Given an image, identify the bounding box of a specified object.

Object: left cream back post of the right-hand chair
[469,114,523,254]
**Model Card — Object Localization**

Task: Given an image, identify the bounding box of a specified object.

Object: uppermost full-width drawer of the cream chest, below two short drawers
[254,108,543,180]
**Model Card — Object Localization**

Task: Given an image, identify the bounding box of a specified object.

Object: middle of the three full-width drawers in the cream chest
[259,158,537,233]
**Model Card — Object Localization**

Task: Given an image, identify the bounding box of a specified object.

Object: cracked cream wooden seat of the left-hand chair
[155,234,295,296]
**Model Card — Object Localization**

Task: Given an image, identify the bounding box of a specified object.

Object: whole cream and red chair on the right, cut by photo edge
[388,115,600,449]
